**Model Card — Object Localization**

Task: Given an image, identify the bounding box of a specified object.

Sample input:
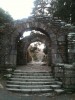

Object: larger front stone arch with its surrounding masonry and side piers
[4,17,72,65]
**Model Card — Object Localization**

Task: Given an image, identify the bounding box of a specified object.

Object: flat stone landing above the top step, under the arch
[16,61,51,72]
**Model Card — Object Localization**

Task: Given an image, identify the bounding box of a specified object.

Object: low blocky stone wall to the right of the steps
[54,63,75,91]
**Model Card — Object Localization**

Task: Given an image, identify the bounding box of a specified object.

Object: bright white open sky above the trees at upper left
[0,0,34,20]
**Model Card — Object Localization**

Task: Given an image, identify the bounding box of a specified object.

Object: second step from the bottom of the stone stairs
[7,85,51,89]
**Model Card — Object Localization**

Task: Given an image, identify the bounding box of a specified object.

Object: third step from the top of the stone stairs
[12,75,53,79]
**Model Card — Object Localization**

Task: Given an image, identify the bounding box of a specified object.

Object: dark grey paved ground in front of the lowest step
[0,89,75,100]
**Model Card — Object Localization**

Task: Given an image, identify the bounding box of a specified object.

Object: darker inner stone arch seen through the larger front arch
[17,33,52,65]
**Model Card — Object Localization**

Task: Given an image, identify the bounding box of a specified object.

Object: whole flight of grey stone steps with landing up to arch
[7,62,64,96]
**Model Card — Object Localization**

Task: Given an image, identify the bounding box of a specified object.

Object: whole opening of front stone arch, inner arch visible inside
[17,30,51,65]
